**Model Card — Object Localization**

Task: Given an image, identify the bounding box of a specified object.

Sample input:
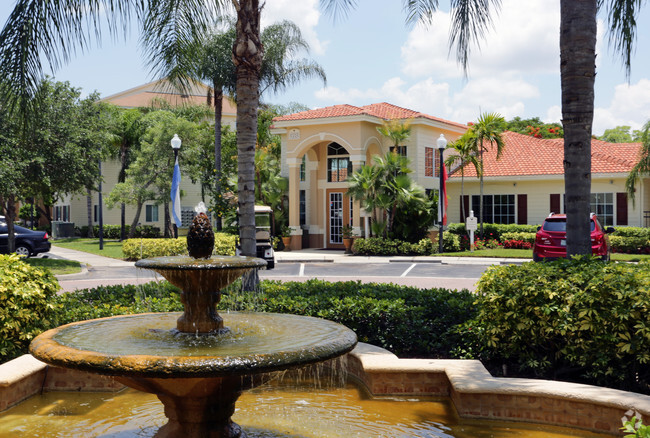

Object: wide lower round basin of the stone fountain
[30,312,356,378]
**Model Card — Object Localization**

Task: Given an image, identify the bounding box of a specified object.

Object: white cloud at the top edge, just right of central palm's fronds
[262,0,327,55]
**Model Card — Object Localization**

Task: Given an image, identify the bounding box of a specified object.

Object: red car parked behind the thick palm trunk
[533,213,615,262]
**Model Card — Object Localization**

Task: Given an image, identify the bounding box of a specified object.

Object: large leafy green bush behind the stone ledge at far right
[471,257,650,392]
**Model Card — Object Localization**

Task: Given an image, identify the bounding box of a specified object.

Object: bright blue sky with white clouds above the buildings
[0,0,650,135]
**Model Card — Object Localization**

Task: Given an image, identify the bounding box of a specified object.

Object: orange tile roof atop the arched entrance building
[273,102,467,128]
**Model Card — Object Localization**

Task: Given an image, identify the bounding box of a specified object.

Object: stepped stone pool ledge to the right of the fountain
[349,343,650,435]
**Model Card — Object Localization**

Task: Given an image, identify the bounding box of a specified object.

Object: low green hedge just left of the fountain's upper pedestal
[57,281,183,324]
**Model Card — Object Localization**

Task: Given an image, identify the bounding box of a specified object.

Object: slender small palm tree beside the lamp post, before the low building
[469,113,506,238]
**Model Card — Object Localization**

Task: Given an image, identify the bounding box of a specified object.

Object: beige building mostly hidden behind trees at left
[52,80,237,231]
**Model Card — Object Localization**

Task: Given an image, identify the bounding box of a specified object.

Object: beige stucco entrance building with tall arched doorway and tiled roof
[272,103,467,249]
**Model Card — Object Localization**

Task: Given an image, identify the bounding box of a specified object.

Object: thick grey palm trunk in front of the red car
[560,0,598,257]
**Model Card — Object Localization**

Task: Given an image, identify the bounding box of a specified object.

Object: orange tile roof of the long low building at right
[450,131,641,178]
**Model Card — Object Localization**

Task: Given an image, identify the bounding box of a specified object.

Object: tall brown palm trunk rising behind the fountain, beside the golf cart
[233,0,263,290]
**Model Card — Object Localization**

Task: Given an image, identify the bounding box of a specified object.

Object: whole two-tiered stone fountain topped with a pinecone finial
[30,207,357,438]
